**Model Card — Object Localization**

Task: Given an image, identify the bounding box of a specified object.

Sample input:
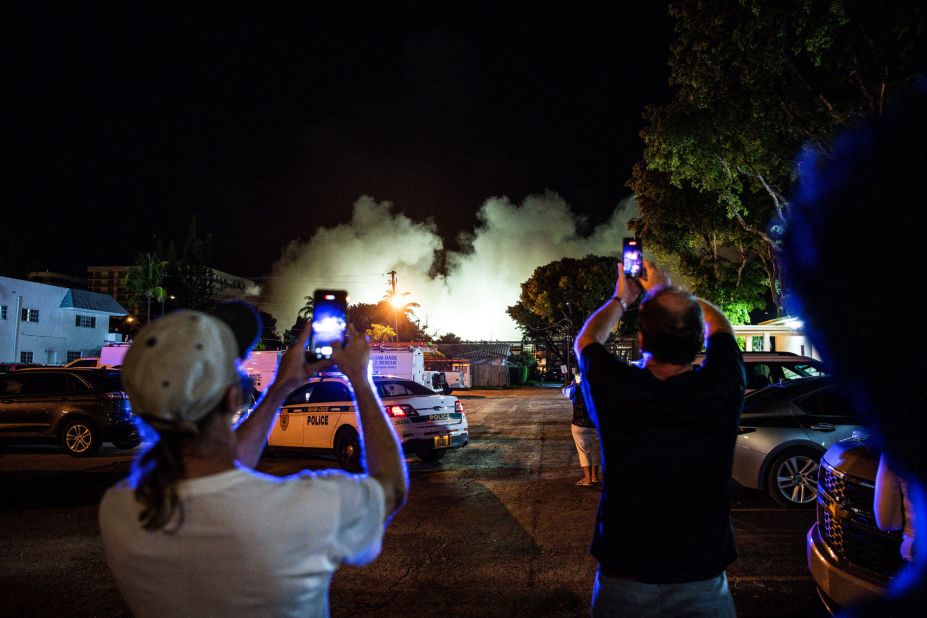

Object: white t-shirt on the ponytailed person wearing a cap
[100,468,384,618]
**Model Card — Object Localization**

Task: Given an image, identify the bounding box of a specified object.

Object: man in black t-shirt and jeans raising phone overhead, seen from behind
[576,262,745,616]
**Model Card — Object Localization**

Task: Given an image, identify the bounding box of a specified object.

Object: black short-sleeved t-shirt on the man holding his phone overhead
[580,333,745,583]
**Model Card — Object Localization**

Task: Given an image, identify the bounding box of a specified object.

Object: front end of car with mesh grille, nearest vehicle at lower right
[807,434,903,613]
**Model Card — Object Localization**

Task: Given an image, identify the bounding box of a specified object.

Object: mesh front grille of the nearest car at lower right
[818,461,902,577]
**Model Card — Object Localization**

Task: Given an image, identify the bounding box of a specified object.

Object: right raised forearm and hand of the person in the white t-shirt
[332,325,409,518]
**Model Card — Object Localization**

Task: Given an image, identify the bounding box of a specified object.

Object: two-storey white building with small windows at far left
[0,277,127,365]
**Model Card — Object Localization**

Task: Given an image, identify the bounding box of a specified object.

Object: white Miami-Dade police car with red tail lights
[267,373,470,471]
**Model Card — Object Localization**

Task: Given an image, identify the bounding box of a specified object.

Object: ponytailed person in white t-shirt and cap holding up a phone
[100,303,408,617]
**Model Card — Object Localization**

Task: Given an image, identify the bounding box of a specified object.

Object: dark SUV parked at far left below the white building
[0,367,141,457]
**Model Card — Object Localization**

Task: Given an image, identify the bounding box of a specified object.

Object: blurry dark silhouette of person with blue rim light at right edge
[782,84,927,616]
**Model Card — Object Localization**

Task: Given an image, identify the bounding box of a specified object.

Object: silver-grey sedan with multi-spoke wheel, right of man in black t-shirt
[732,377,863,508]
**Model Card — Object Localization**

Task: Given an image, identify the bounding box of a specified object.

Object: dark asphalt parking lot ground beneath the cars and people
[0,388,823,616]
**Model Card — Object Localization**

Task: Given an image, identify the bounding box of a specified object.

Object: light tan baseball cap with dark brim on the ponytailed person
[122,301,261,424]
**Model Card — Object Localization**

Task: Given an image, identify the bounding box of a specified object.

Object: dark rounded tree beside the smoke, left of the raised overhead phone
[506,255,617,365]
